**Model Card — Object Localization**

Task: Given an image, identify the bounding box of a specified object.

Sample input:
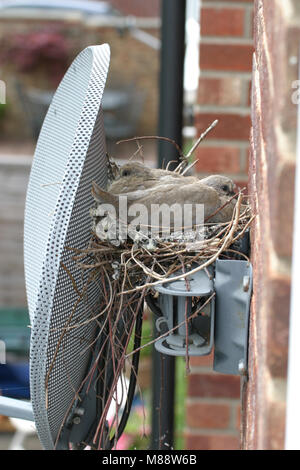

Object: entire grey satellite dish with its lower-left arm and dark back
[0,44,142,450]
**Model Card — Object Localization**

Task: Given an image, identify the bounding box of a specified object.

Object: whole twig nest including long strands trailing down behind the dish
[63,122,253,449]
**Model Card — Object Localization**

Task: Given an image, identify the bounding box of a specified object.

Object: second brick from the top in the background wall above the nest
[200,43,253,72]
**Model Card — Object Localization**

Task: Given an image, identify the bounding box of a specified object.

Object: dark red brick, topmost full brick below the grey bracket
[188,373,240,398]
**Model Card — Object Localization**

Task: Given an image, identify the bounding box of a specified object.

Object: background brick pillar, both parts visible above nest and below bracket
[185,0,253,450]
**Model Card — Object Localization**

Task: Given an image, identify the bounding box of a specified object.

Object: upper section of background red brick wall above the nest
[195,0,253,190]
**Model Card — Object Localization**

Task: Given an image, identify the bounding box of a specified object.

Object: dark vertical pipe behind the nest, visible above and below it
[151,0,186,450]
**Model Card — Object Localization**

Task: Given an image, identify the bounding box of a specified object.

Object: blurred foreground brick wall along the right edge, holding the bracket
[243,0,300,449]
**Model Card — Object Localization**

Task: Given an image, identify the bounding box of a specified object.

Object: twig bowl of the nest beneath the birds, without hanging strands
[79,191,254,296]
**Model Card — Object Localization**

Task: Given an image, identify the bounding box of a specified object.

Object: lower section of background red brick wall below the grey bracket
[185,355,240,450]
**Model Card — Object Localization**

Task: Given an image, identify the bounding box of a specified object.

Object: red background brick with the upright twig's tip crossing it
[195,113,251,141]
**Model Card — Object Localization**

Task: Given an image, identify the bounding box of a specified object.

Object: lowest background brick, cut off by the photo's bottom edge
[185,434,240,450]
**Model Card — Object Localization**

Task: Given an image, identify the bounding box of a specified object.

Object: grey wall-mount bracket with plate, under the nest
[155,260,252,376]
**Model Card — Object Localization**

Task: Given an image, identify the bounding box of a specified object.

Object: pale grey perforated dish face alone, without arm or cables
[24,44,110,449]
